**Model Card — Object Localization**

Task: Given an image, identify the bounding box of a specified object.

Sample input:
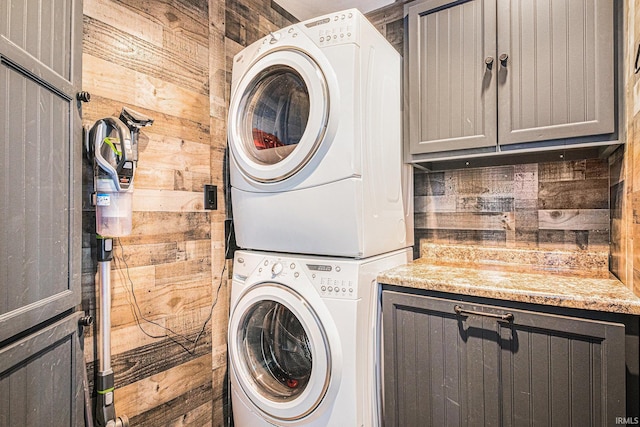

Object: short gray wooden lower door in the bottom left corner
[0,313,84,427]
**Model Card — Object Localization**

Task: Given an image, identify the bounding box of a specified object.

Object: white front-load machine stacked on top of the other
[228,9,413,258]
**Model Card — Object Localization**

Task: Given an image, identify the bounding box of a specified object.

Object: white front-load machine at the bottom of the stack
[229,249,410,427]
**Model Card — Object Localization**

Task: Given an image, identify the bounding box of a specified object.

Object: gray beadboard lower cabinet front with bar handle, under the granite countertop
[382,290,637,427]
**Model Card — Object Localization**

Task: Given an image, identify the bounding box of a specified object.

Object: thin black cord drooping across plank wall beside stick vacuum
[114,224,231,355]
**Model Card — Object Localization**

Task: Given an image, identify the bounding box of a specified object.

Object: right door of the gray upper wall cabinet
[497,0,615,145]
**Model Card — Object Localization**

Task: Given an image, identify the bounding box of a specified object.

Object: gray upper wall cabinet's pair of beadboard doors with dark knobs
[405,0,616,160]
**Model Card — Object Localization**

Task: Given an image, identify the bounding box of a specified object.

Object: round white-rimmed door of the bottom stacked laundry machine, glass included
[229,283,331,421]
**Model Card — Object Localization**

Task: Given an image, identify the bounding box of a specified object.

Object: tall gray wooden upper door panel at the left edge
[0,0,82,341]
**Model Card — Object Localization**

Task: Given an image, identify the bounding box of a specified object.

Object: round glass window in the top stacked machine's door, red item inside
[240,65,310,165]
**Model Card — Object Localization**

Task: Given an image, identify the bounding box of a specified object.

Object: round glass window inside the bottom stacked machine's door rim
[238,300,313,402]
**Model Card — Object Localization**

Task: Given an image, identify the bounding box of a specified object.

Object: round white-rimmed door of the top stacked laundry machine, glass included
[228,48,329,183]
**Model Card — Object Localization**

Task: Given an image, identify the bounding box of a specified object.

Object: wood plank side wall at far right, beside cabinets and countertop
[609,0,640,296]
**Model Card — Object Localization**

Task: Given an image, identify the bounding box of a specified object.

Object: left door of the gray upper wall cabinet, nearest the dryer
[405,0,497,154]
